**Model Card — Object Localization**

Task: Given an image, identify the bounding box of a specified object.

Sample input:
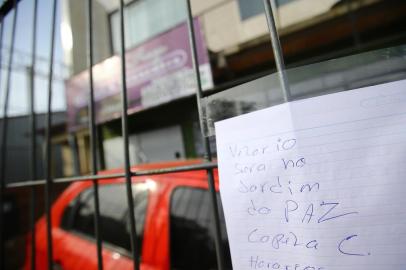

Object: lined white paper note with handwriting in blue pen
[215,81,406,270]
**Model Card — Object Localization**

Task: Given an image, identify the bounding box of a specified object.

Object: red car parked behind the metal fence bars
[25,162,231,270]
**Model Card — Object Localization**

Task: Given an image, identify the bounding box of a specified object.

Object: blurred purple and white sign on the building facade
[66,19,213,131]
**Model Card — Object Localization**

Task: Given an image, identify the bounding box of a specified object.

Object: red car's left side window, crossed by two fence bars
[61,183,148,254]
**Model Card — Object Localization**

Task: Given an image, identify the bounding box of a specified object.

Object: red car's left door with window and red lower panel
[54,183,148,269]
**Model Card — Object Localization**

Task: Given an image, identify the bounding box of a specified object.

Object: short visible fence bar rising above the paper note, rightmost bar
[263,0,291,102]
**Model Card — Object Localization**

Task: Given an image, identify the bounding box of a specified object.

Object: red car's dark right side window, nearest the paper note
[170,187,232,270]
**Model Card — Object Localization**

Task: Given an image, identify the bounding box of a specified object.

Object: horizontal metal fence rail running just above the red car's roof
[6,162,217,188]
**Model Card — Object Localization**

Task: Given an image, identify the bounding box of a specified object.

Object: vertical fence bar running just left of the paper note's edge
[186,0,224,270]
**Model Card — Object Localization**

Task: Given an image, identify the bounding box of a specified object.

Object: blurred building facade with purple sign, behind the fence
[61,0,406,173]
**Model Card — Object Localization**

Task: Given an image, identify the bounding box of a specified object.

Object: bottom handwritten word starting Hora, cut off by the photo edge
[248,256,325,270]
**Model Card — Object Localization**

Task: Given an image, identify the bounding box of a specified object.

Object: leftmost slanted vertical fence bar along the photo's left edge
[0,0,18,269]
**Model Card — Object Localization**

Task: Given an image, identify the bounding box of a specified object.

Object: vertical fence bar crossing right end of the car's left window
[120,0,140,270]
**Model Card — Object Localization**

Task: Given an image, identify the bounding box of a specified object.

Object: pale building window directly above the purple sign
[110,0,186,53]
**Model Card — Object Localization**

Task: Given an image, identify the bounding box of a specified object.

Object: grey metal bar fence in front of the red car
[0,0,290,270]
